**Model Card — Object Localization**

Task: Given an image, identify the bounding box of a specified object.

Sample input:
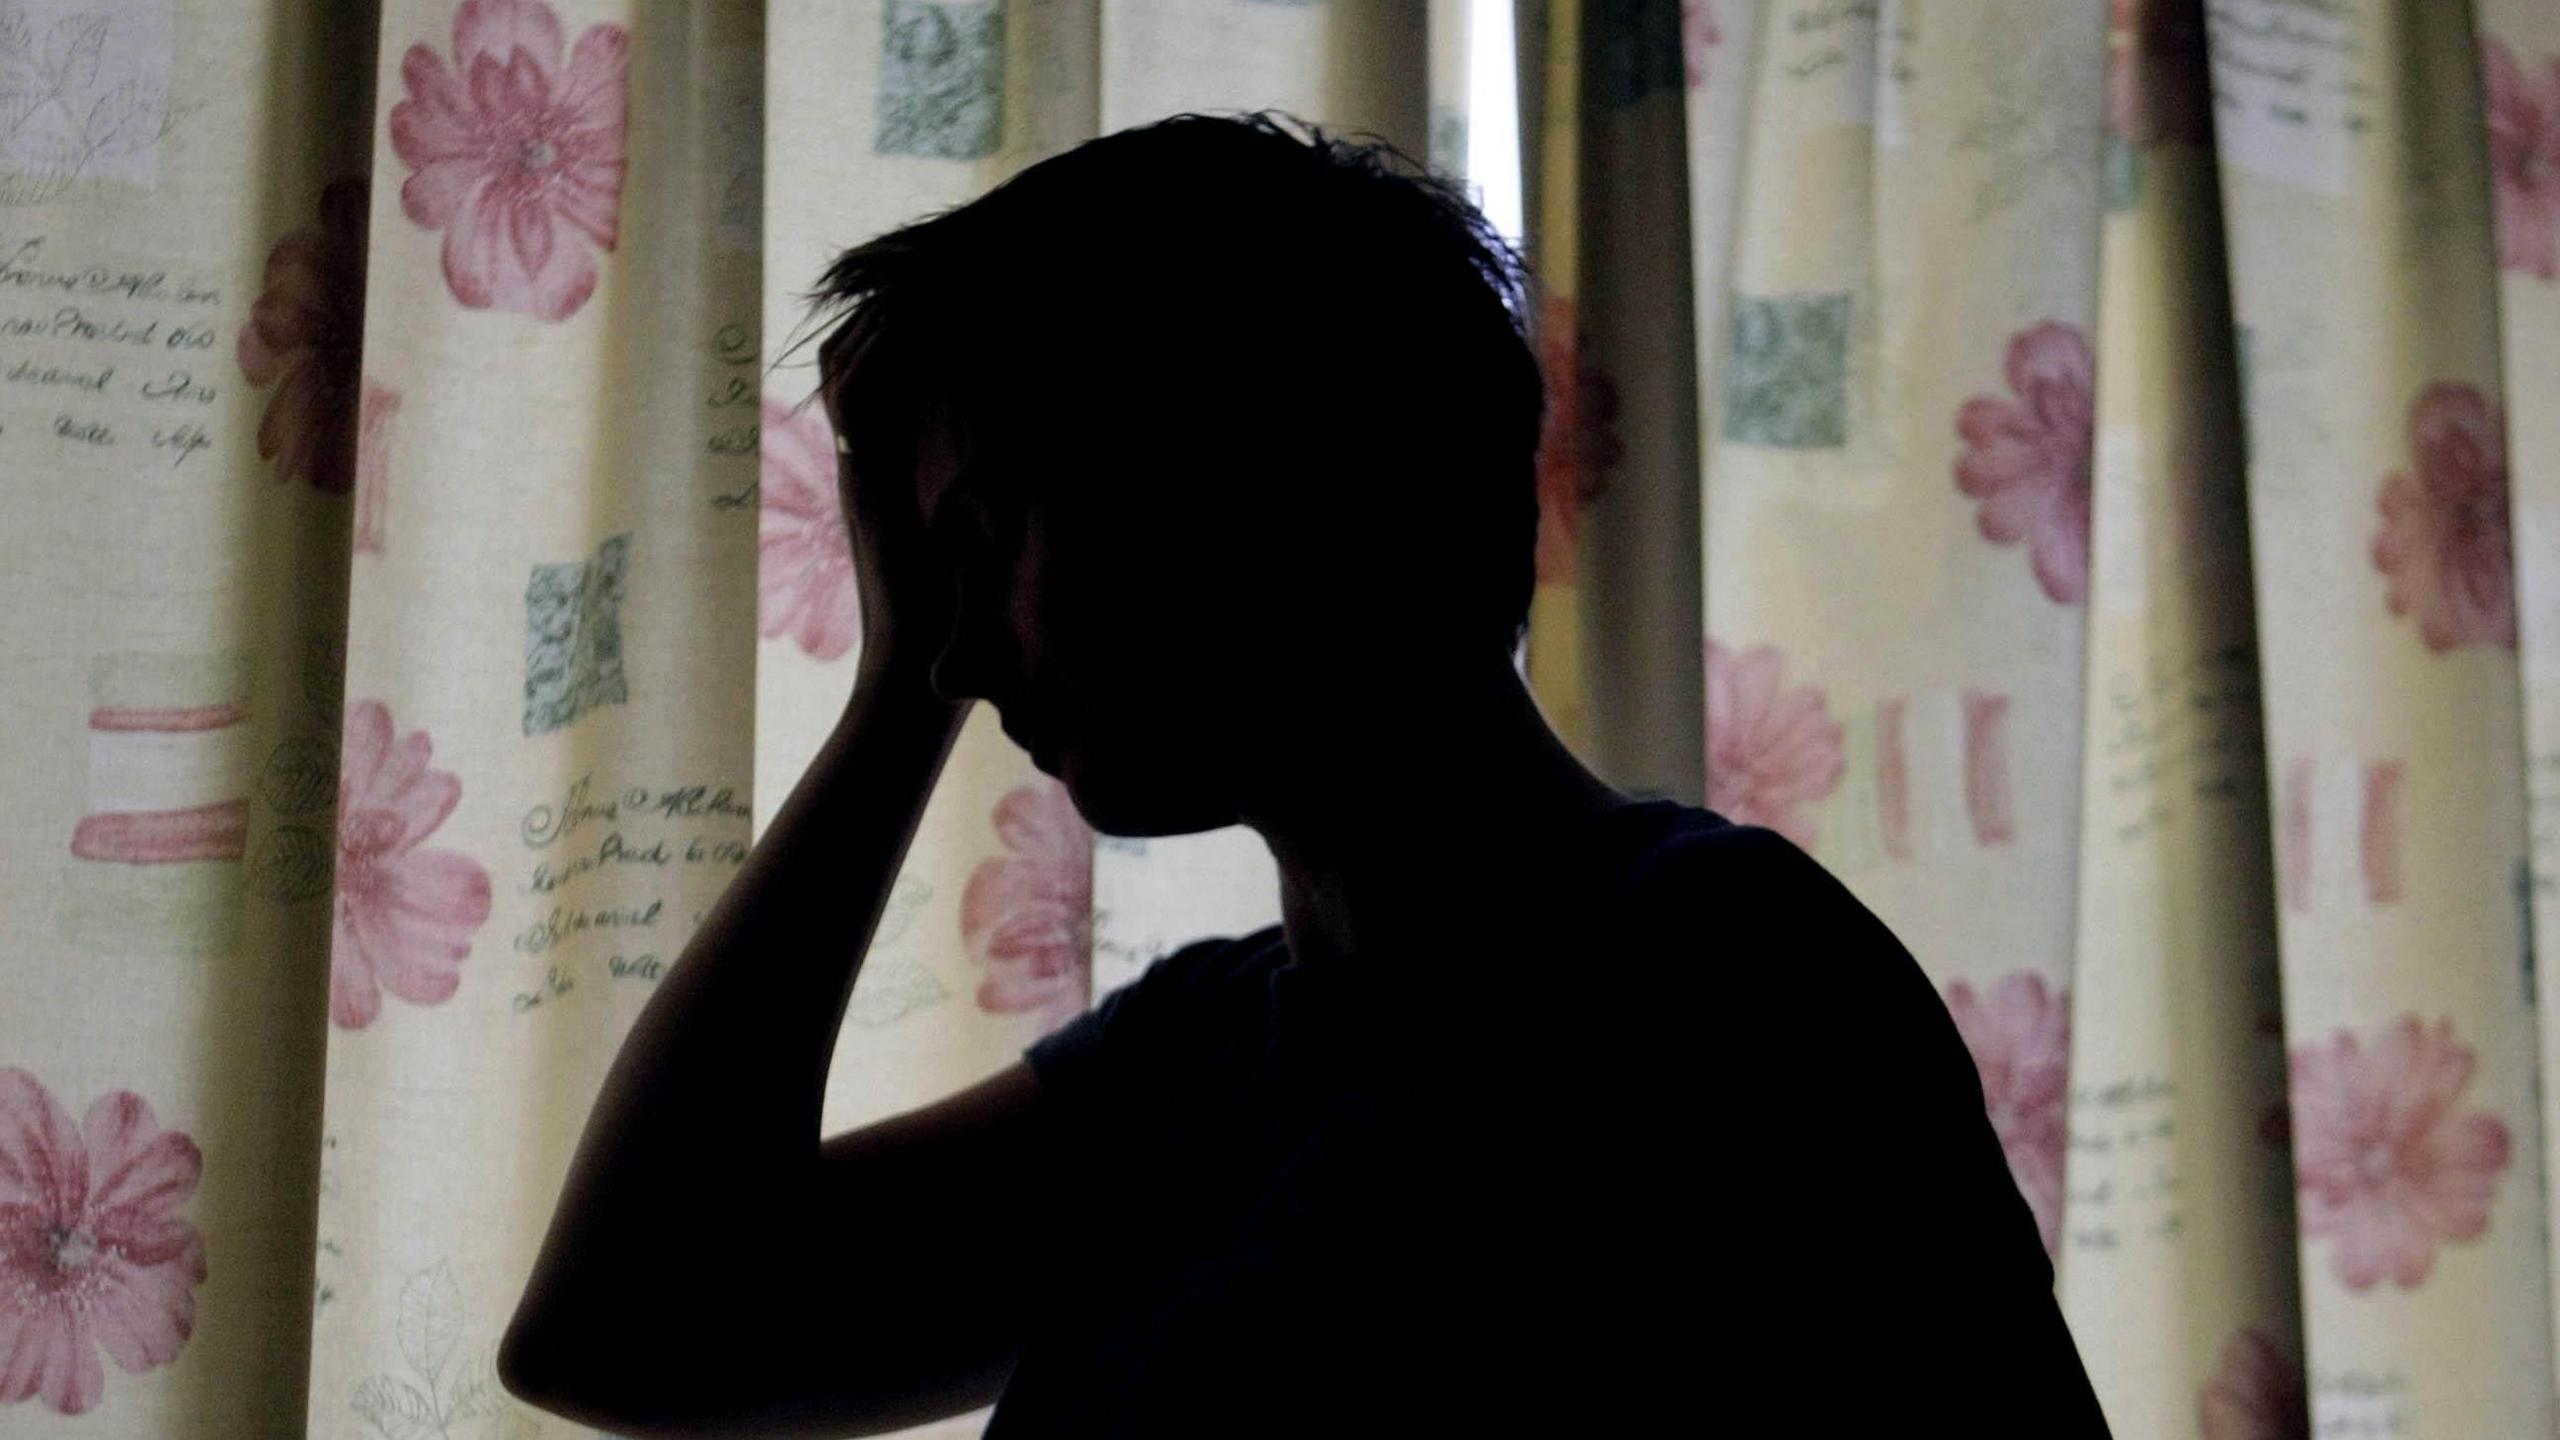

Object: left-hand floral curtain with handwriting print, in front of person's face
[0,0,1467,1440]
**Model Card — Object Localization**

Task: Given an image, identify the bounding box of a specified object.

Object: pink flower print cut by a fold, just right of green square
[1956,320,2097,605]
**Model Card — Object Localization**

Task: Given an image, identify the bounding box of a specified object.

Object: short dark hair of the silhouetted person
[778,110,1546,656]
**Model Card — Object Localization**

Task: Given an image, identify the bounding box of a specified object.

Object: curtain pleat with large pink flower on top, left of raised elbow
[307,0,765,1435]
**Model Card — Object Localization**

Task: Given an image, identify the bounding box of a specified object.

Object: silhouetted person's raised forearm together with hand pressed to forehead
[499,371,1019,1437]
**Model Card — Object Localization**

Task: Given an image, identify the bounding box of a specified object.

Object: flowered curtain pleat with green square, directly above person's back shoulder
[1690,0,2107,1291]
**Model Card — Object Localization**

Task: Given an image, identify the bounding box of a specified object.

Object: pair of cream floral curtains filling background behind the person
[0,0,2560,1440]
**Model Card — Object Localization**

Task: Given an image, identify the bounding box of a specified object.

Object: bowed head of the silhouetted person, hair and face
[788,115,1544,835]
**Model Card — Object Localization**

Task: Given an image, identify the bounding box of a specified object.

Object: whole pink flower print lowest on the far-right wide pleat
[2291,1015,2514,1291]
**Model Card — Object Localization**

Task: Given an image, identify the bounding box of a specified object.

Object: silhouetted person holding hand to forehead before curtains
[499,115,2104,1440]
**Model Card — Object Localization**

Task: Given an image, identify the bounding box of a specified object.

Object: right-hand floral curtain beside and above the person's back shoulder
[1638,0,2560,1440]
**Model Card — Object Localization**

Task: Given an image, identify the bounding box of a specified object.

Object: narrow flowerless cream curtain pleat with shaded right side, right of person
[2061,31,2299,1435]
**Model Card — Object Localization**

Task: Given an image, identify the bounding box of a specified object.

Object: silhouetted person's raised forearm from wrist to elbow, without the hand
[499,650,968,1394]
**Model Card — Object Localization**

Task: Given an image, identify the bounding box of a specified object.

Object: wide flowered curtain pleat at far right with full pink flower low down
[2214,5,2552,1435]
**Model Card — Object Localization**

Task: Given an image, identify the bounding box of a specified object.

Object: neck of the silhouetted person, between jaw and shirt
[1244,661,1636,963]
